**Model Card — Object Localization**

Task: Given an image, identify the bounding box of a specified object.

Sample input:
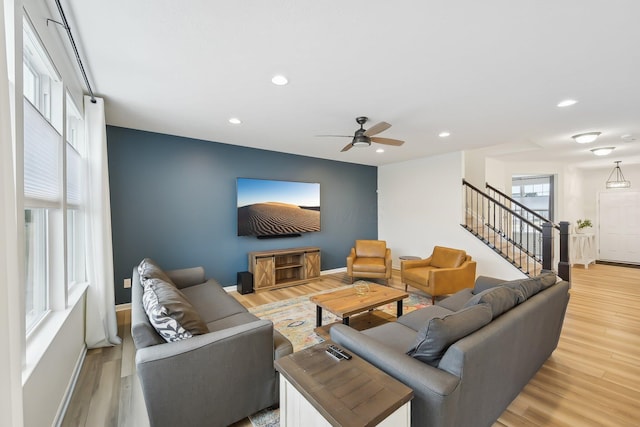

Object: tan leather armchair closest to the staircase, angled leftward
[400,246,476,304]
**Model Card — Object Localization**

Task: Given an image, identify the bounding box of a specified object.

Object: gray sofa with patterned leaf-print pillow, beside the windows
[131,259,293,427]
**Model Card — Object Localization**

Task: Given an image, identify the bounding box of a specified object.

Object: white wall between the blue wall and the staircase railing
[378,152,523,279]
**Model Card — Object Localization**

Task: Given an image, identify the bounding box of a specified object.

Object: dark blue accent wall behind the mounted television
[107,126,378,304]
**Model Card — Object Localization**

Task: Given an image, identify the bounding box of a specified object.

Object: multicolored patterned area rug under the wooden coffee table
[249,286,431,427]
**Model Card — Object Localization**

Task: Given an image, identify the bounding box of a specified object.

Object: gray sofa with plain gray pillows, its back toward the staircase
[331,272,569,427]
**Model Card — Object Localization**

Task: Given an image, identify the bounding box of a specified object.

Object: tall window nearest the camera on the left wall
[23,19,64,333]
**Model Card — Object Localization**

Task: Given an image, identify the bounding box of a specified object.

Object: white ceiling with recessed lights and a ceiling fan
[55,0,640,167]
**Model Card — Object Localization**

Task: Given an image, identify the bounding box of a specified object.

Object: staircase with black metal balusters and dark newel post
[461,179,570,280]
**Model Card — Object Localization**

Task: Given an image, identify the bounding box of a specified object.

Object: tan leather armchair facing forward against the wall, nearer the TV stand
[347,240,391,284]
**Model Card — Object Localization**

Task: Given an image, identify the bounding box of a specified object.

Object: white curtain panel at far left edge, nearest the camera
[0,2,23,426]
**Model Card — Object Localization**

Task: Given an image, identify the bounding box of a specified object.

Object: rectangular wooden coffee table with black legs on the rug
[309,283,409,328]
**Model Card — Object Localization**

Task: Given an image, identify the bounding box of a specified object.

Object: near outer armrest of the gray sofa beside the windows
[136,320,278,426]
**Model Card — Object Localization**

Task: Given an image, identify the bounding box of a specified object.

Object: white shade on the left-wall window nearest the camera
[24,99,62,202]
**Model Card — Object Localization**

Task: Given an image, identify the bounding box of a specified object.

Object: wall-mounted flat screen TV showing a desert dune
[237,178,320,238]
